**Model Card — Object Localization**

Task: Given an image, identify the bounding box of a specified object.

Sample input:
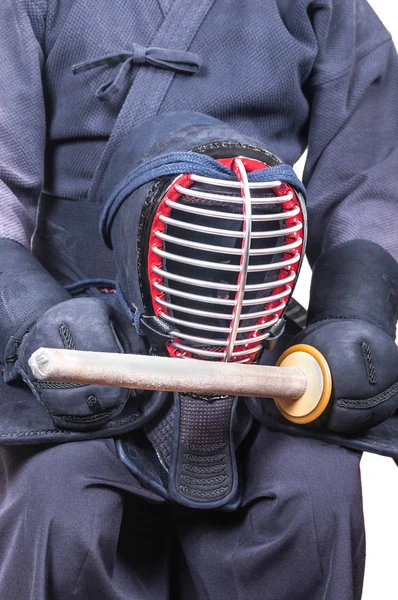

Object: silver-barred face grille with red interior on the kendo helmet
[147,157,304,362]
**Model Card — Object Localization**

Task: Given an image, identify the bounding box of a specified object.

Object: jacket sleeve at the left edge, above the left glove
[0,0,46,247]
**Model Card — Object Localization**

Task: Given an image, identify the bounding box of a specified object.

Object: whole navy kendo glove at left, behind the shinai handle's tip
[0,239,129,431]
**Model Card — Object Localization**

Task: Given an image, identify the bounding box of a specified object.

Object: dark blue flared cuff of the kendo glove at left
[0,238,71,383]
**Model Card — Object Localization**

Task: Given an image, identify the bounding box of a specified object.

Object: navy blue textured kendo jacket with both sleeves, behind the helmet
[0,0,398,279]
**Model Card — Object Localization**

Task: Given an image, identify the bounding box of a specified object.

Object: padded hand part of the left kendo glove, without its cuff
[15,298,130,431]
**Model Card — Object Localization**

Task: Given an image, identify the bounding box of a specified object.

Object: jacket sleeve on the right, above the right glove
[304,0,398,263]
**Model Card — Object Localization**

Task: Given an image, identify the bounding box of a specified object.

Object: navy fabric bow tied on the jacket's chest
[72,44,201,102]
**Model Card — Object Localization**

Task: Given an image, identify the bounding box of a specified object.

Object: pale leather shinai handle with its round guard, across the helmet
[29,346,332,422]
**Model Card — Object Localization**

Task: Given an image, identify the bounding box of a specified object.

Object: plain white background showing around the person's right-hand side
[292,0,398,600]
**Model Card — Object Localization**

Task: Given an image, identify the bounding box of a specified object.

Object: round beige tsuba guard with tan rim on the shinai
[275,344,332,425]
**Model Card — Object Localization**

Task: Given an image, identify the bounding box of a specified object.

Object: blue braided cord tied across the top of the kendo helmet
[100,152,306,248]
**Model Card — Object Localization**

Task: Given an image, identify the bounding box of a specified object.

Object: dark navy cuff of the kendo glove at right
[308,240,398,339]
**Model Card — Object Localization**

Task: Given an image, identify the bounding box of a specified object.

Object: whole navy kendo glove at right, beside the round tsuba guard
[293,240,398,434]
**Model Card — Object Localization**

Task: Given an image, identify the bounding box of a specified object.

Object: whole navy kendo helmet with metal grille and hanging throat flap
[101,113,306,508]
